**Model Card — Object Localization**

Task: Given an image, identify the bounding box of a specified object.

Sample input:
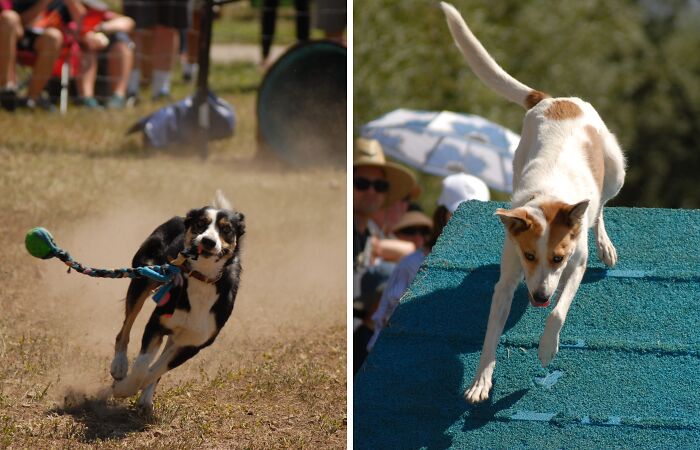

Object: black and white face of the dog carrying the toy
[185,207,245,258]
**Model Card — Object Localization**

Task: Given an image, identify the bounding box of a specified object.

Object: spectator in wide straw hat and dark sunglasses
[352,139,417,369]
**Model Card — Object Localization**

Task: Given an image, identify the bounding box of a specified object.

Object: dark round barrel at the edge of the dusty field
[257,41,347,167]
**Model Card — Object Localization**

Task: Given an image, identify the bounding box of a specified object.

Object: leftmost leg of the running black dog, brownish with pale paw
[110,278,156,380]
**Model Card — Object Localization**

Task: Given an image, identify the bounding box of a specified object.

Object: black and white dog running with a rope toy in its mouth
[111,191,245,408]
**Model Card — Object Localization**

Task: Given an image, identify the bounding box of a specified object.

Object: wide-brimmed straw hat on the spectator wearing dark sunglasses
[352,138,420,205]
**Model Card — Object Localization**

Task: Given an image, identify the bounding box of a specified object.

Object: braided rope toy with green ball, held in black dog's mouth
[24,227,198,306]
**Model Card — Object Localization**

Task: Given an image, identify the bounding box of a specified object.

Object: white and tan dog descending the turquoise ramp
[442,2,625,403]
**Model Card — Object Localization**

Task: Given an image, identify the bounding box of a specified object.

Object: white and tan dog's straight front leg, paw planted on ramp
[464,238,523,403]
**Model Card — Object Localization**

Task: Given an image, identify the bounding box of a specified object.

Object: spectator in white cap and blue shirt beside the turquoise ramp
[367,173,490,351]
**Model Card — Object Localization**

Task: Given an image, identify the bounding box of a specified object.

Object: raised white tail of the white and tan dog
[440,2,549,109]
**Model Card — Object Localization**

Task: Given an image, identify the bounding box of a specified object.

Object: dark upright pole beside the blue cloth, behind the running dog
[194,0,214,159]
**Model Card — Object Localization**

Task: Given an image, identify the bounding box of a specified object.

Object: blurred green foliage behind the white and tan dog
[353,0,700,207]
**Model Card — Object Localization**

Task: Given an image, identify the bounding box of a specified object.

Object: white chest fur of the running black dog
[161,279,218,346]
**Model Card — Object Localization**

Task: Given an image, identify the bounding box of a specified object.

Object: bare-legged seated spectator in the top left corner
[0,0,67,111]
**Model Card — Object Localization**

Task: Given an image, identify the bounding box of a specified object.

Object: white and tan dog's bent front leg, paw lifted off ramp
[537,243,588,367]
